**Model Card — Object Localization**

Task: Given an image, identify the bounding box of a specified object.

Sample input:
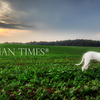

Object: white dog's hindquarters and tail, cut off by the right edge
[75,51,100,71]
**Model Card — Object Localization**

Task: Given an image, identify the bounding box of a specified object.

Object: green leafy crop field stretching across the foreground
[0,44,100,100]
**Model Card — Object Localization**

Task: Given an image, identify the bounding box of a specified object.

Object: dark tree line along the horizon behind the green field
[5,39,100,47]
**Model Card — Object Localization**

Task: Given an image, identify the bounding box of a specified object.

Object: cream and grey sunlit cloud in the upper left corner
[0,0,34,29]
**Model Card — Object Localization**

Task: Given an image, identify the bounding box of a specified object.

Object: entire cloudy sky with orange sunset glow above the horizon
[0,0,100,43]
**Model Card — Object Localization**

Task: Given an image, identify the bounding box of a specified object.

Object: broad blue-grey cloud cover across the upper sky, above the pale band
[0,0,100,30]
